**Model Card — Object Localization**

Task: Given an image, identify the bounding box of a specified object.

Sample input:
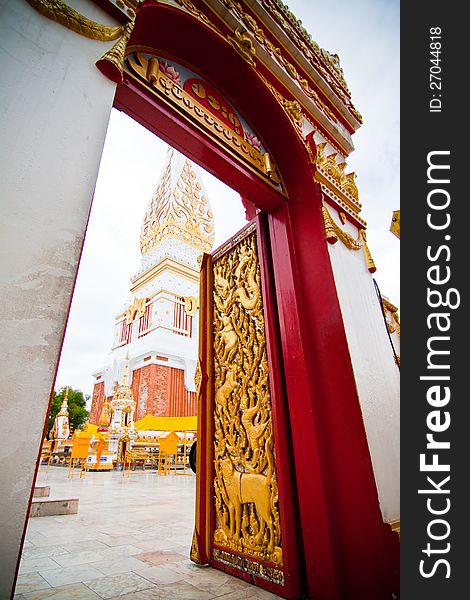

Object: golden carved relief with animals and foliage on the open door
[213,232,282,566]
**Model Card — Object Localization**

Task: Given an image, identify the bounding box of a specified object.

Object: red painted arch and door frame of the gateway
[111,2,398,600]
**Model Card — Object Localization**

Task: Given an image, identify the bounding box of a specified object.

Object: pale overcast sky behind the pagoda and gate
[55,0,400,404]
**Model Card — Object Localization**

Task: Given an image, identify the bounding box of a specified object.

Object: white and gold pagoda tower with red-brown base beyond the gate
[90,147,214,424]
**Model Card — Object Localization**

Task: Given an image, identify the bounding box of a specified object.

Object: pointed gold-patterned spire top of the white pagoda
[140,147,214,256]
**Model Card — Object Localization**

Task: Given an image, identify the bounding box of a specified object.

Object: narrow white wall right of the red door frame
[328,207,400,522]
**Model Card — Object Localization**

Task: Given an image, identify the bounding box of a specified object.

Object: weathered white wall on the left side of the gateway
[0,0,115,598]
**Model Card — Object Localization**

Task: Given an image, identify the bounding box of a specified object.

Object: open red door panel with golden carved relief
[191,216,301,598]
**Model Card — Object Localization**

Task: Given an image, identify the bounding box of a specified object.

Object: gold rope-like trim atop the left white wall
[26,0,126,42]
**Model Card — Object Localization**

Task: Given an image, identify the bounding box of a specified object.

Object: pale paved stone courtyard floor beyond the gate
[15,466,278,600]
